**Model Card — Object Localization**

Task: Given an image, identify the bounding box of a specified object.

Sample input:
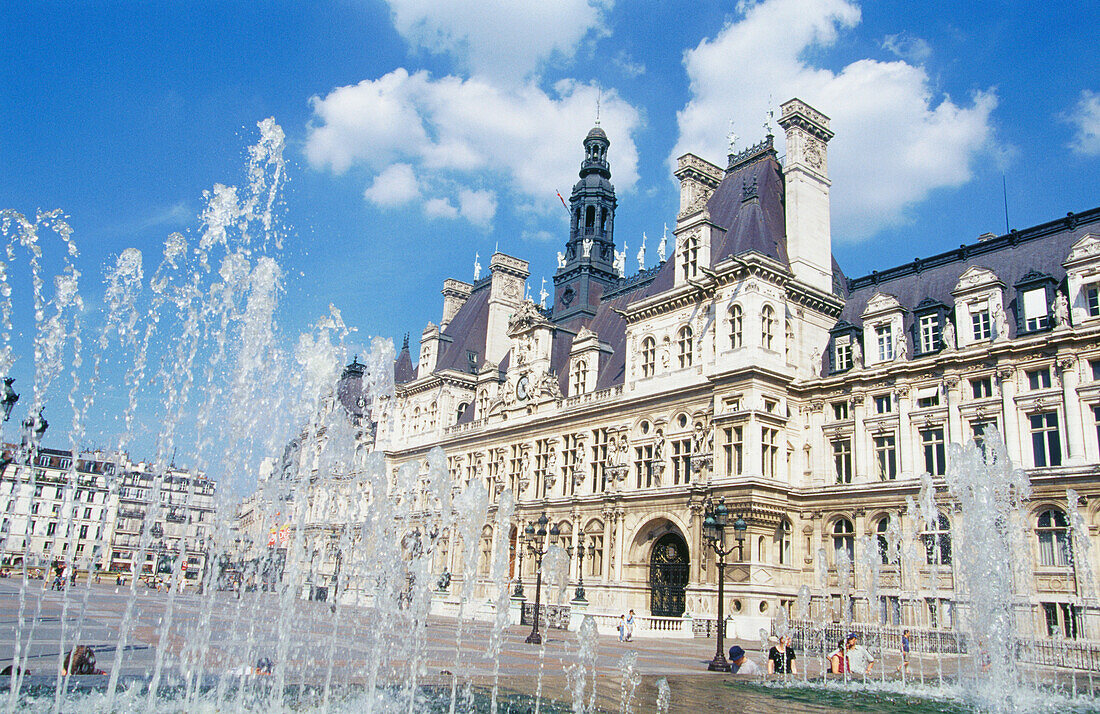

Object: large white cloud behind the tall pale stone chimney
[670,0,997,240]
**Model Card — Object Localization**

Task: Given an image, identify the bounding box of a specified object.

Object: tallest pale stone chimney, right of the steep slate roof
[779,99,833,293]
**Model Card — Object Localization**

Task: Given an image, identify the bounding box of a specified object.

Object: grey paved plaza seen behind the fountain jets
[0,579,1086,712]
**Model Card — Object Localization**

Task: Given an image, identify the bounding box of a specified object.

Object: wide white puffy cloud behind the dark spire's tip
[306,69,641,223]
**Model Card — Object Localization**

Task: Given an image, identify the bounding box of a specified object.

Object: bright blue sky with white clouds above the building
[0,0,1100,459]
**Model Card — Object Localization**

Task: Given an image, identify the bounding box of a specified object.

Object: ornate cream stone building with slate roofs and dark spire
[378,99,1100,637]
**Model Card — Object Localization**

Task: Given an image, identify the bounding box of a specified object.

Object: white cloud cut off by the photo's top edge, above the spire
[386,0,612,80]
